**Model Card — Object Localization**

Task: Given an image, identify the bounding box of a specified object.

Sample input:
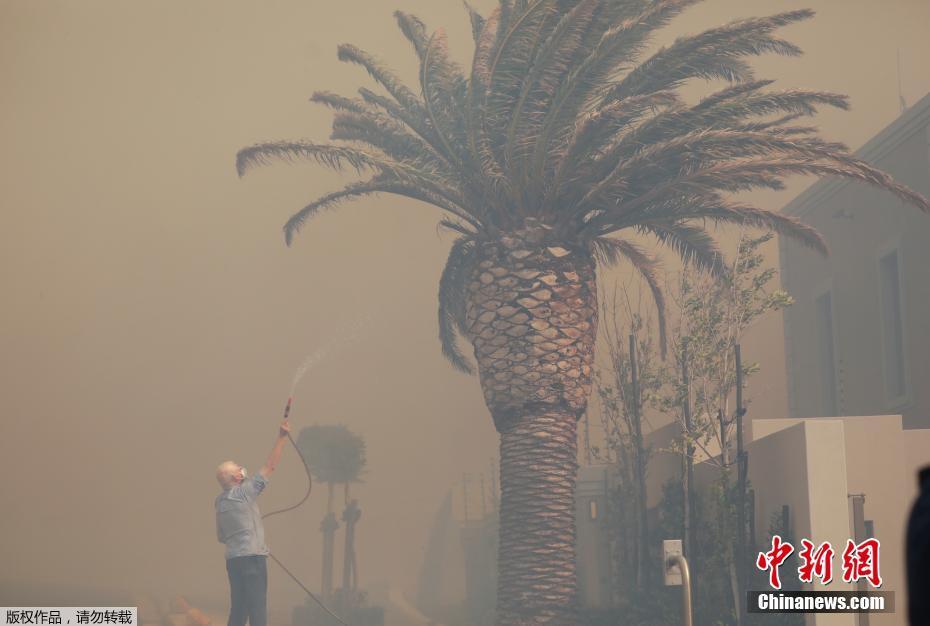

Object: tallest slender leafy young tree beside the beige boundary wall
[665,233,793,620]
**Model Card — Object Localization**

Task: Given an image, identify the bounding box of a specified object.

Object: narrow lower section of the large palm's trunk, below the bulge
[497,413,578,626]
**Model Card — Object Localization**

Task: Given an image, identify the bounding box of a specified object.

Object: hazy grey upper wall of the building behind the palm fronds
[780,96,930,428]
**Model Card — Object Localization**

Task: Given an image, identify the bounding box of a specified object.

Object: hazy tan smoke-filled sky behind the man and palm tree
[0,0,930,607]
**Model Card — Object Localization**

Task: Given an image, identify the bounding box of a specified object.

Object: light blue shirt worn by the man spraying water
[214,474,269,559]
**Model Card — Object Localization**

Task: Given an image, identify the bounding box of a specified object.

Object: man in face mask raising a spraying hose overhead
[214,419,291,626]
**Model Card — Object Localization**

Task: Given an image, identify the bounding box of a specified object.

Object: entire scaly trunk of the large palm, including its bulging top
[465,220,597,626]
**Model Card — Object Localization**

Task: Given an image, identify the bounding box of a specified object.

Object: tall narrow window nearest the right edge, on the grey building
[878,250,907,405]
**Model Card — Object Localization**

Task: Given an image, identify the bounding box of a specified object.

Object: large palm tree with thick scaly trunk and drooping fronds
[237,0,930,626]
